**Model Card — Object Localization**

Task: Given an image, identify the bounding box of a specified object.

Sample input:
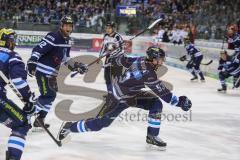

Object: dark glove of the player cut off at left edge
[23,92,37,116]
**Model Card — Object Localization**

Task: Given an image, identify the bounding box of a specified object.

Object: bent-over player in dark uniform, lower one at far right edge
[218,51,240,92]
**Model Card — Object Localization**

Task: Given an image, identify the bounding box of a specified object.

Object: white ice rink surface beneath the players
[0,49,240,160]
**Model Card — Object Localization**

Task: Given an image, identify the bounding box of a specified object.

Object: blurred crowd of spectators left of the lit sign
[0,0,110,28]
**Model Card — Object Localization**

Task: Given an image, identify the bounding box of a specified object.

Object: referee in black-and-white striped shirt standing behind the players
[99,22,124,92]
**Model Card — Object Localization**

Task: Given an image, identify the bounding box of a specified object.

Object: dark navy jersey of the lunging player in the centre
[113,55,176,105]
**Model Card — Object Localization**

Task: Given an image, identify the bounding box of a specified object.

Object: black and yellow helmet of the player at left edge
[0,28,17,49]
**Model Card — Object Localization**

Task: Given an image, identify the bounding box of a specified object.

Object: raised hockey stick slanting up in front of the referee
[71,18,163,78]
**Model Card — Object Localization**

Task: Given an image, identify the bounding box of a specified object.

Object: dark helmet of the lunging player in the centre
[146,46,165,61]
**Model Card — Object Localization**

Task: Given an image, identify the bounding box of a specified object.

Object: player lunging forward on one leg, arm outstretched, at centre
[58,46,192,147]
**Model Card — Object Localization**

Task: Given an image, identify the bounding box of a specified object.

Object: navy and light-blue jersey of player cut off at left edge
[0,47,31,100]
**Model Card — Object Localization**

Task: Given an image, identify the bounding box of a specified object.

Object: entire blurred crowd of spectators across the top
[0,0,240,39]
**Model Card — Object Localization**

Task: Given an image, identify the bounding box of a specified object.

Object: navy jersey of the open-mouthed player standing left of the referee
[30,31,71,76]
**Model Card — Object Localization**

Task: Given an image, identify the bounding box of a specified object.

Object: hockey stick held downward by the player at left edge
[0,71,62,147]
